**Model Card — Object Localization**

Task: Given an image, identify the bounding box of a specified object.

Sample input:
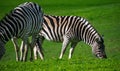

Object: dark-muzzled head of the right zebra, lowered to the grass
[92,37,107,58]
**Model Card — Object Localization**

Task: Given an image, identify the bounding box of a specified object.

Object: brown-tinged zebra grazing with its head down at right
[34,15,107,59]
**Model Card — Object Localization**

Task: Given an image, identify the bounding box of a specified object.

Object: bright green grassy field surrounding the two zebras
[0,0,120,71]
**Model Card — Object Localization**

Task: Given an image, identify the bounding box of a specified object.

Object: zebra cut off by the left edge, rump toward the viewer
[0,2,43,61]
